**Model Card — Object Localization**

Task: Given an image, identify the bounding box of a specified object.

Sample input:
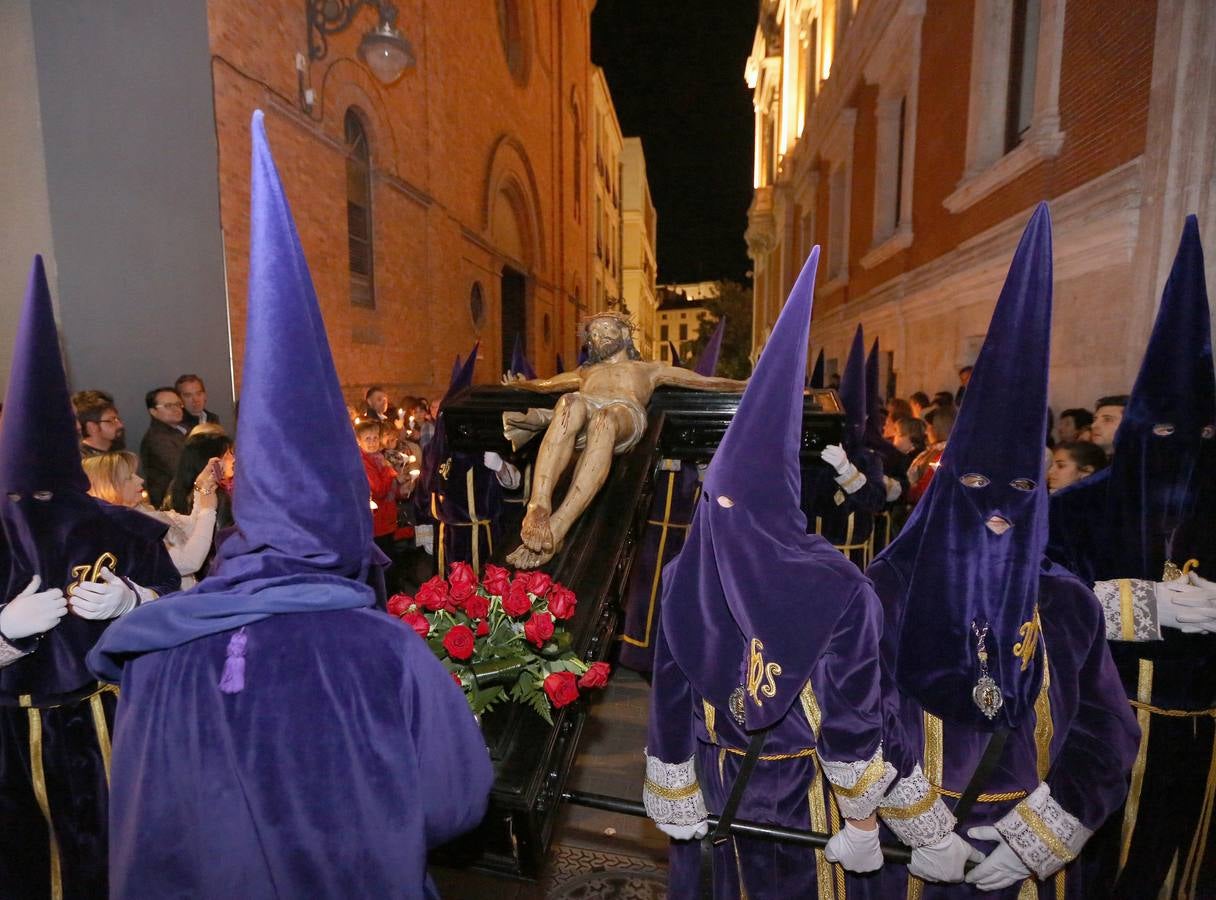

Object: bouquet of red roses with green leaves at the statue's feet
[388,562,610,725]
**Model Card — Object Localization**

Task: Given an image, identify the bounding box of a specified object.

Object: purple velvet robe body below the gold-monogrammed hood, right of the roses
[647,586,883,900]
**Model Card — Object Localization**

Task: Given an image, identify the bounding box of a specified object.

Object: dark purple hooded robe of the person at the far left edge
[0,257,180,898]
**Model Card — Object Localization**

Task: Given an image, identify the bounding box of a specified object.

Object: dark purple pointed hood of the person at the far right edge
[1108,215,1216,580]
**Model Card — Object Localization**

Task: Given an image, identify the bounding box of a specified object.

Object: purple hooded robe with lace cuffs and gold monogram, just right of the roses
[643,247,894,900]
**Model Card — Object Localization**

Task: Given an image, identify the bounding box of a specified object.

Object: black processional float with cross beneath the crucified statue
[433,386,844,878]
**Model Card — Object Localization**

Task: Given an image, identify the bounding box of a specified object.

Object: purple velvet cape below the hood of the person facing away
[103,609,483,900]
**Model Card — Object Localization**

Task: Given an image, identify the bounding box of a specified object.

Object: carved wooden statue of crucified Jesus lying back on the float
[503,314,747,569]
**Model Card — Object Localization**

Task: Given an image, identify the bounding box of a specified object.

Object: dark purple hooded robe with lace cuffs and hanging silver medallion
[849,204,1137,900]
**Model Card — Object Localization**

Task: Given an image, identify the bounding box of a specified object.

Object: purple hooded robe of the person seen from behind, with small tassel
[89,111,492,900]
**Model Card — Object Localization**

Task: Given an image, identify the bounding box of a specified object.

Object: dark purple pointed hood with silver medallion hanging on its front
[878,203,1052,730]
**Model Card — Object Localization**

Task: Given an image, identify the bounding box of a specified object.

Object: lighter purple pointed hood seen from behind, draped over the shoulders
[89,109,379,680]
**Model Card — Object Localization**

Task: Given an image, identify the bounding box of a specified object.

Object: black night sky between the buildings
[591,0,756,282]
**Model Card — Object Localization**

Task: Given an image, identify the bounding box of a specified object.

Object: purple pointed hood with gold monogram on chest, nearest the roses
[662,247,863,731]
